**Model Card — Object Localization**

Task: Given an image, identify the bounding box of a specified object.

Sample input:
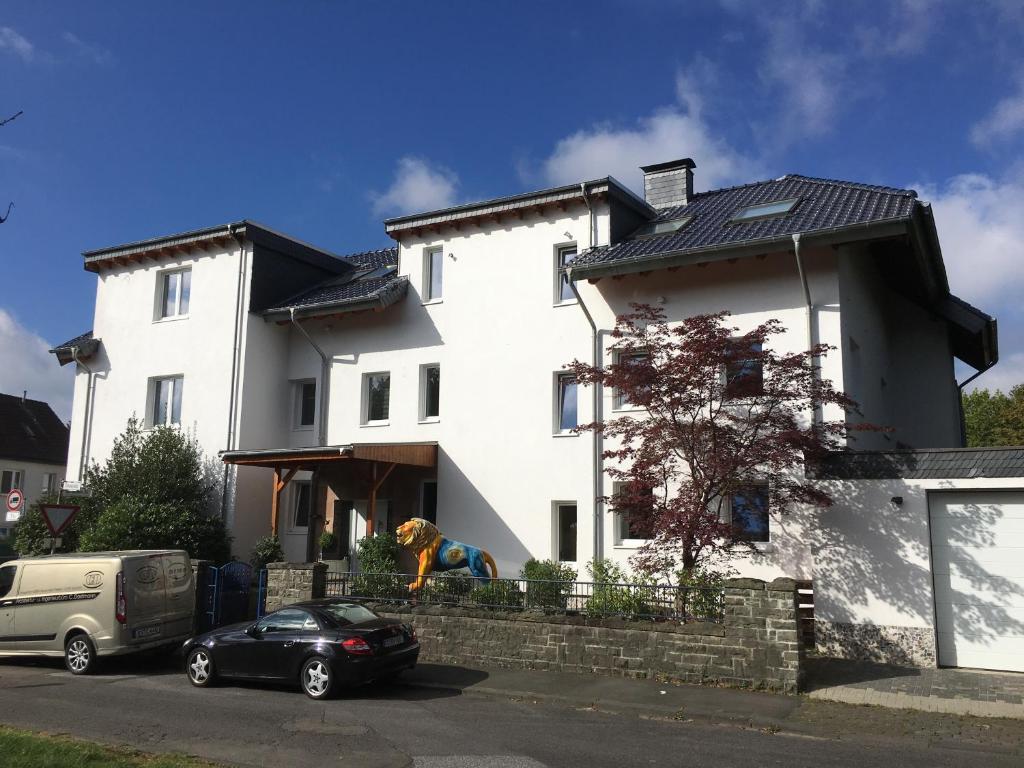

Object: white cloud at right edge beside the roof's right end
[916,173,1024,312]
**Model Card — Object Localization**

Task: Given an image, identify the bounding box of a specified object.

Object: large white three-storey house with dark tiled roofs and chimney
[54,160,1024,662]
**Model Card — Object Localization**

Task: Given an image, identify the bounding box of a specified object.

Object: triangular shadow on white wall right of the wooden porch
[437,447,531,578]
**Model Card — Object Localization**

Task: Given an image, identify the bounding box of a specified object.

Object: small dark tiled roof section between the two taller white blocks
[262,248,409,319]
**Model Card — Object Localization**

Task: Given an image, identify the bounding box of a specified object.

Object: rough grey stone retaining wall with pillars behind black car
[267,563,804,692]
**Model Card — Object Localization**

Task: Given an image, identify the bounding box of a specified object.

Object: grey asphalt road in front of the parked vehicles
[0,658,1024,768]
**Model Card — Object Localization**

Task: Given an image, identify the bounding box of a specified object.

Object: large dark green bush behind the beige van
[17,418,230,562]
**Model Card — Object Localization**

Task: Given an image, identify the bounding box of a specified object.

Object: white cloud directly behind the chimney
[523,66,757,195]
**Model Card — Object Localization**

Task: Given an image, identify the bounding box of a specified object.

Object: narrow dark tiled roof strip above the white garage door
[814,447,1024,480]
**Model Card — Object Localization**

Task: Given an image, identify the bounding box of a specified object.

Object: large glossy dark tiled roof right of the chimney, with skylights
[573,174,916,267]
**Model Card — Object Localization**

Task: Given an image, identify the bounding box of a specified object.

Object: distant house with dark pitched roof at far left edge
[0,394,69,539]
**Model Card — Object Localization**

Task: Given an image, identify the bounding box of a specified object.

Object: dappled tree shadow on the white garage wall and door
[806,466,1024,664]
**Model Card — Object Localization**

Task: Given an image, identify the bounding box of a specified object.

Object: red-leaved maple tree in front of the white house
[567,304,879,572]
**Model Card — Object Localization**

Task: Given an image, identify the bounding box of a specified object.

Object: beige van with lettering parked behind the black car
[0,550,196,675]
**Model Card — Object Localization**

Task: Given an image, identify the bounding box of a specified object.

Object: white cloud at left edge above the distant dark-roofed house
[0,309,75,420]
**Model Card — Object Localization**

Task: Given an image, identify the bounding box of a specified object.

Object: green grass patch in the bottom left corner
[0,726,222,768]
